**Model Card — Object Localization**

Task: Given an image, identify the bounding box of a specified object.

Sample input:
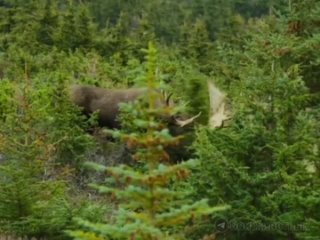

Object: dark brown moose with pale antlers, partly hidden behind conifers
[69,82,230,162]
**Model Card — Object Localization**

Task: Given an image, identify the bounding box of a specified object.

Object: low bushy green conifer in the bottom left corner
[0,161,70,237]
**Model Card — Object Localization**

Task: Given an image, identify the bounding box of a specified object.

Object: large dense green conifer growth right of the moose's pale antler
[190,3,320,239]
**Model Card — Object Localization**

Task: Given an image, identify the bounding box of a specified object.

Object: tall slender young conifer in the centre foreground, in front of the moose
[69,42,225,240]
